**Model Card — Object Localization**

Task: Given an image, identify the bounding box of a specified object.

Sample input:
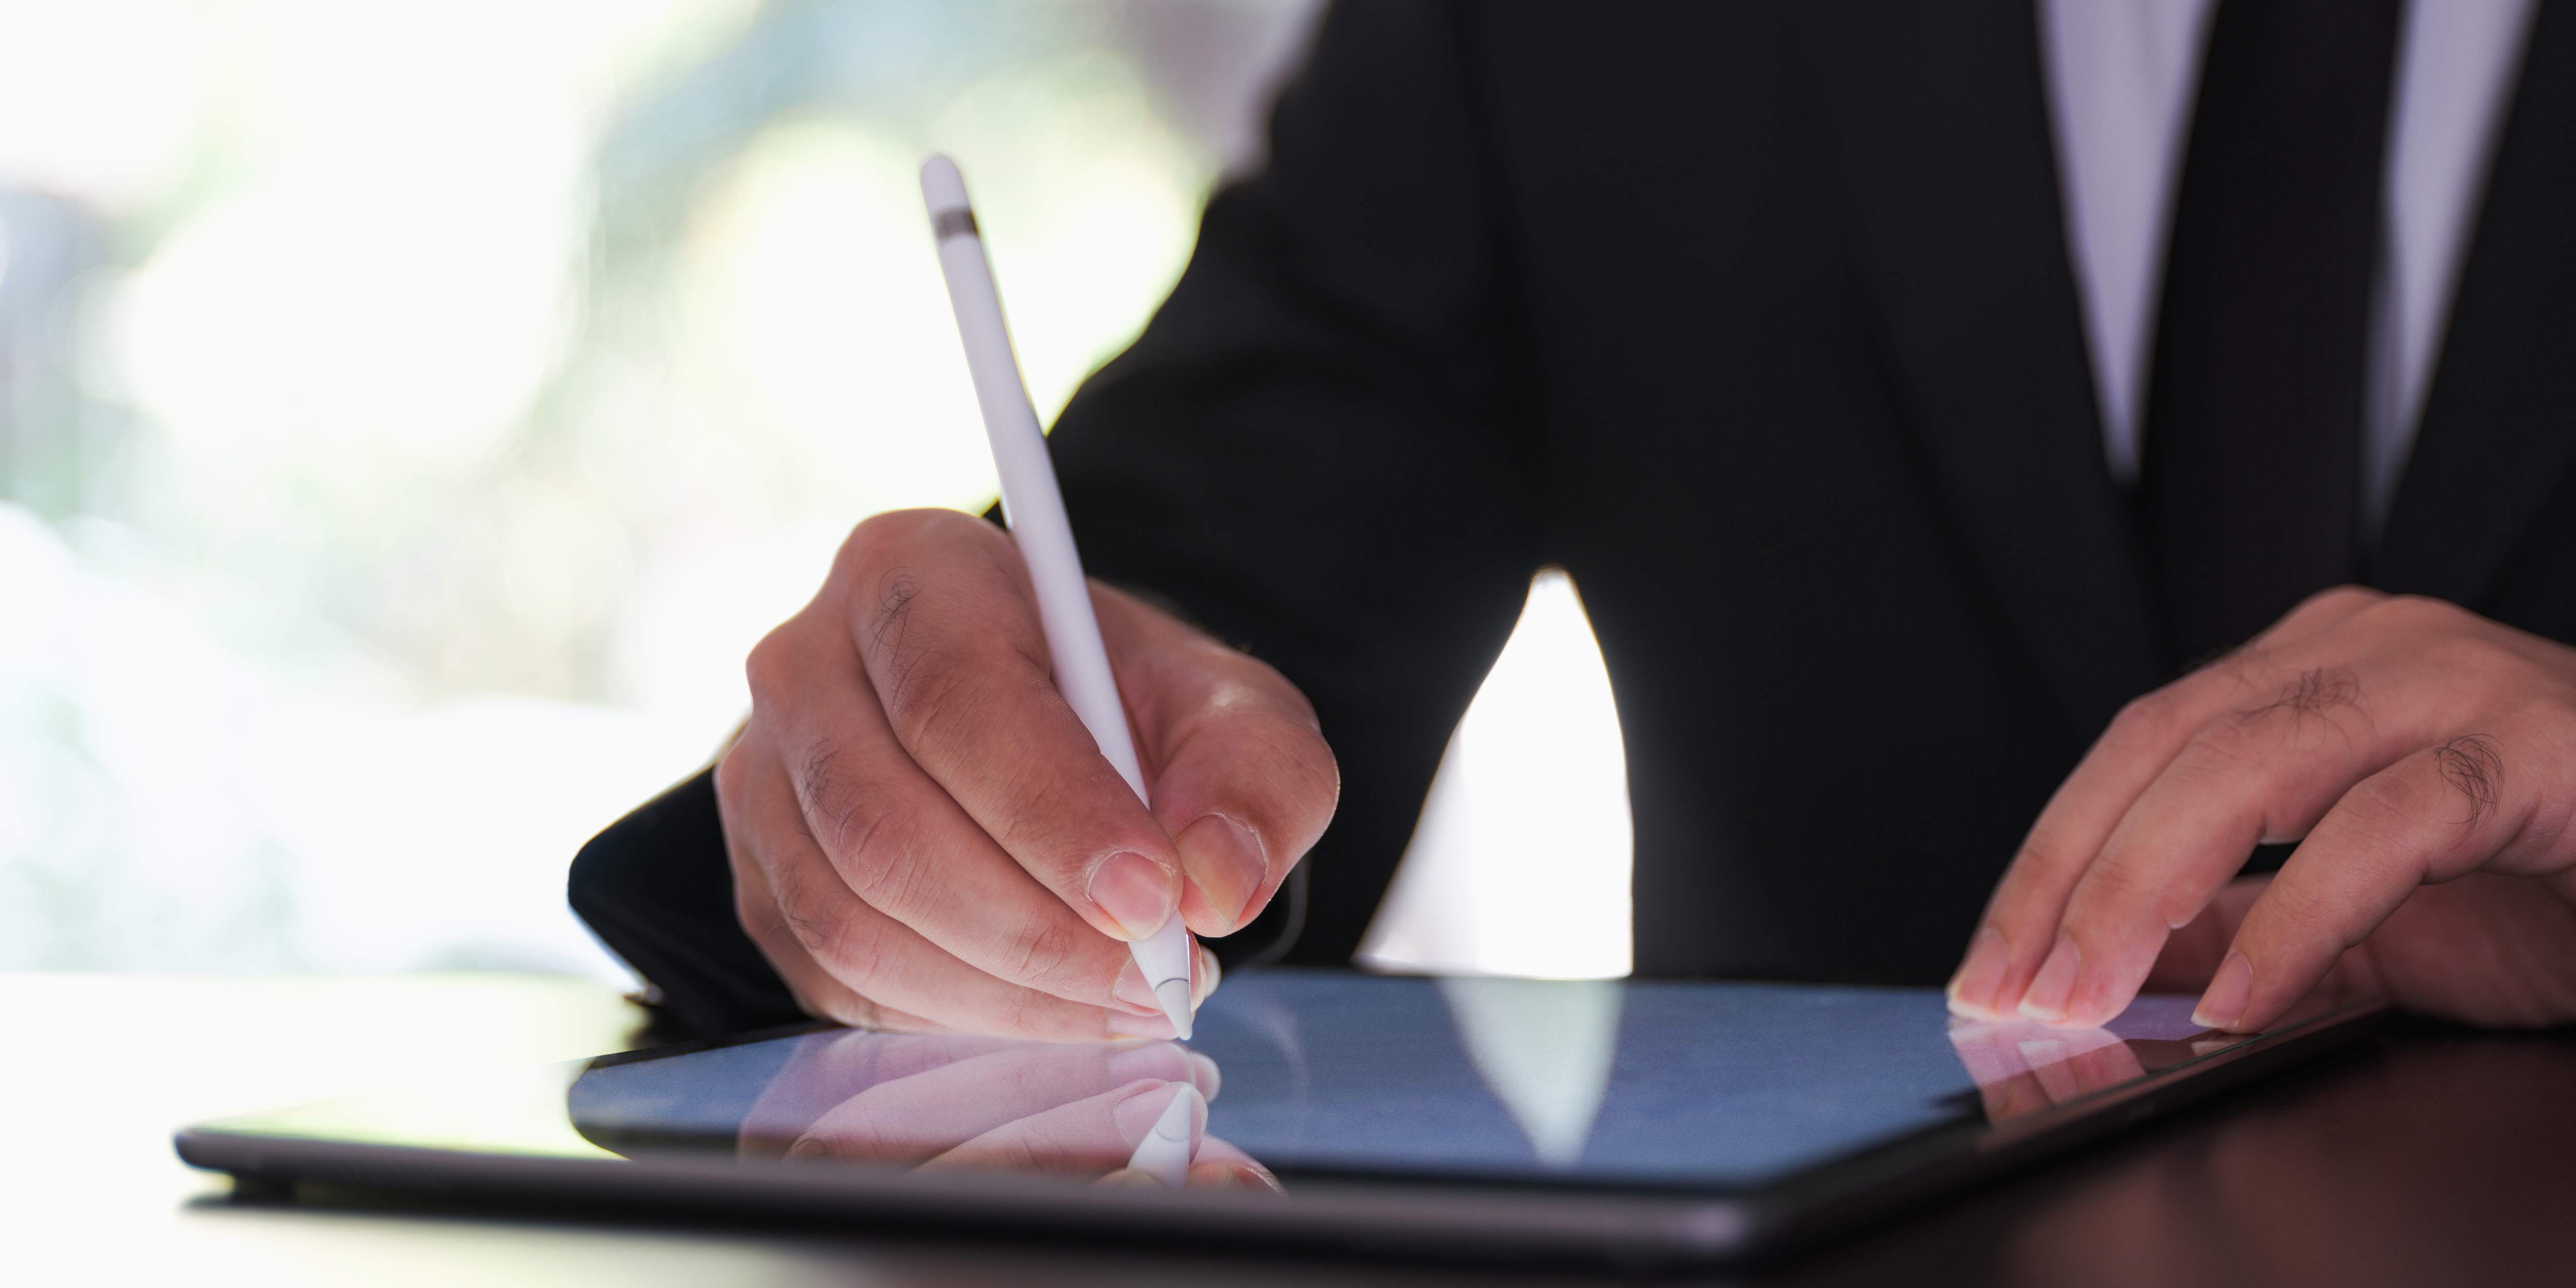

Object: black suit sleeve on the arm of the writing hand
[572,0,1540,1033]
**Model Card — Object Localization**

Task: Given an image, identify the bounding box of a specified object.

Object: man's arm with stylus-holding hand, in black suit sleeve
[574,3,1538,1036]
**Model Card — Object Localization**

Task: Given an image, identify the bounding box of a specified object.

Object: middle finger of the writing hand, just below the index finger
[750,603,1162,1015]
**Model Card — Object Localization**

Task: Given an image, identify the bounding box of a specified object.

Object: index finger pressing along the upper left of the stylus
[845,510,1180,940]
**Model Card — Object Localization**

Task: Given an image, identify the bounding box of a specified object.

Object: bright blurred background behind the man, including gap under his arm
[0,0,1628,984]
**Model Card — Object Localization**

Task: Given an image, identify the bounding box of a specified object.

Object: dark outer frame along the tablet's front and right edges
[175,979,2385,1267]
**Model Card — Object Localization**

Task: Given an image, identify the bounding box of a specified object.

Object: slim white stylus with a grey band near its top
[922,155,1190,1038]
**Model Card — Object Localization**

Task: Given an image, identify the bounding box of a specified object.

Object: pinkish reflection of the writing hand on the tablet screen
[737,1030,1280,1193]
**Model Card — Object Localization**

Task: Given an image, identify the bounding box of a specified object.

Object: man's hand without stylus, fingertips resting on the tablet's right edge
[1950,587,2576,1030]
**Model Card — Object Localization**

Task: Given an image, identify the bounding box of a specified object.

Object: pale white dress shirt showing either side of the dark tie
[2038,0,2532,533]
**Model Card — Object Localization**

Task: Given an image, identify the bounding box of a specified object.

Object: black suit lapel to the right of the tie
[2372,3,2576,605]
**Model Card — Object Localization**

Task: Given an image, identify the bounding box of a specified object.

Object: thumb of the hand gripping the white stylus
[1092,587,1342,935]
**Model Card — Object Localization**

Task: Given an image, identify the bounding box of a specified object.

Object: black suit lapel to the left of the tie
[1808,0,2166,739]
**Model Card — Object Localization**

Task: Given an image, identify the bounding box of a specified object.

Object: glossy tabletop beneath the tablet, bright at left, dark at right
[0,974,2576,1288]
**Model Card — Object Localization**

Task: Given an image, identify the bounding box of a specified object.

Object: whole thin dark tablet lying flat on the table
[178,969,2378,1265]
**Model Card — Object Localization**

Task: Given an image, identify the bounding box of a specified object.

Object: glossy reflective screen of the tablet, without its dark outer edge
[191,971,2349,1193]
